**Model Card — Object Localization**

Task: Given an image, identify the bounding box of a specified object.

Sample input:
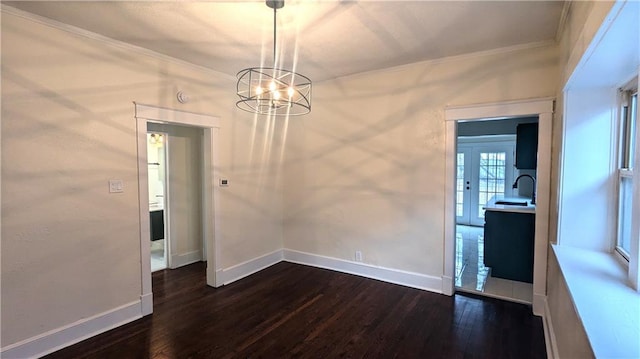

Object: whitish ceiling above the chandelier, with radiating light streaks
[3,0,564,81]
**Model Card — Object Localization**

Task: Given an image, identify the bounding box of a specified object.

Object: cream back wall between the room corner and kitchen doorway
[284,46,557,277]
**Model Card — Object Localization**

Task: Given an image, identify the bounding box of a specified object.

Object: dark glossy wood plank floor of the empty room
[47,262,546,358]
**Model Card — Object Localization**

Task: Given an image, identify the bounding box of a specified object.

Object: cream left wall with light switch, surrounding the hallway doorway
[0,9,282,348]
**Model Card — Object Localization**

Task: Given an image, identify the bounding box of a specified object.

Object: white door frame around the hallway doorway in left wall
[133,102,221,316]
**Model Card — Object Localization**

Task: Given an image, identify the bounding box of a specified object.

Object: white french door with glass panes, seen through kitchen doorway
[456,143,514,226]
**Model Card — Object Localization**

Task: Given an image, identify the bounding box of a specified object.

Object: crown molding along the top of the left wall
[0,4,236,81]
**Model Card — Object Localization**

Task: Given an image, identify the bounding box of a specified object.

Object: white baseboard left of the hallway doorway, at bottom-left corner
[0,300,142,359]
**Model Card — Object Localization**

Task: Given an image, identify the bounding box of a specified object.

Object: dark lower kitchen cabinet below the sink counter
[484,210,535,283]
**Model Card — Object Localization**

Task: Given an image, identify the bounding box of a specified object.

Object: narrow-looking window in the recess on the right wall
[616,88,638,260]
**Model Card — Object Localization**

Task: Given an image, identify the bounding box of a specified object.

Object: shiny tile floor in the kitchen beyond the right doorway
[455,225,533,304]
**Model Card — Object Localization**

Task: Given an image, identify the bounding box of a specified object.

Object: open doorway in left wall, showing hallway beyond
[147,123,206,272]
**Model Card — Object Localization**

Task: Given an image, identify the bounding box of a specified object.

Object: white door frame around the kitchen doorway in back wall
[442,98,554,316]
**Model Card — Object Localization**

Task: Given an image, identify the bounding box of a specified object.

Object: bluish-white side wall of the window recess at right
[558,88,617,251]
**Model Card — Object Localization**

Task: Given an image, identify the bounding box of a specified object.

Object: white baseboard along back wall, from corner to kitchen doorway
[283,249,442,294]
